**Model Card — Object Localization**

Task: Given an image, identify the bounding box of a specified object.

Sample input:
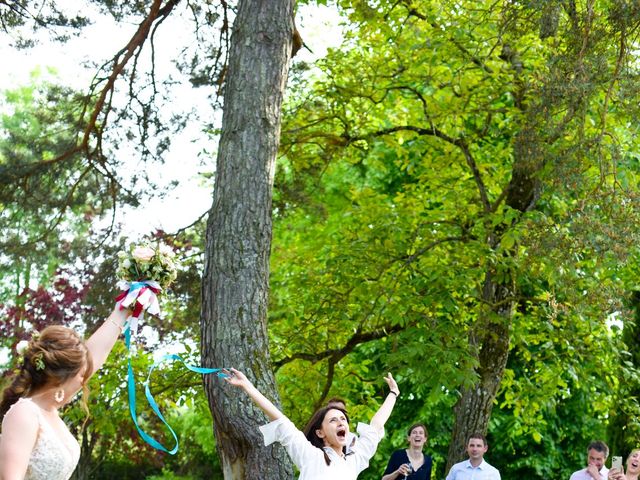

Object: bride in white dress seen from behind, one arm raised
[0,304,128,480]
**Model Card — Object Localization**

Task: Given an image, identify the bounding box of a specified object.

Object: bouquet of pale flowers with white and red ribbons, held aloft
[116,243,178,332]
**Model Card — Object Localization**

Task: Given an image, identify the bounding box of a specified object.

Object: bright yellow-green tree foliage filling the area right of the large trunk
[270,1,639,478]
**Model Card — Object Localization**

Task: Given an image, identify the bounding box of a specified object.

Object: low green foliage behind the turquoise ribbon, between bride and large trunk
[64,330,220,480]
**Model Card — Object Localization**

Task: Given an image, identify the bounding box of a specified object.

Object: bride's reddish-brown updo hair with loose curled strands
[0,325,93,421]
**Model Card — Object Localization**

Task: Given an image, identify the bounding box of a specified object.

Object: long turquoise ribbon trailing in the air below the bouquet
[124,325,228,455]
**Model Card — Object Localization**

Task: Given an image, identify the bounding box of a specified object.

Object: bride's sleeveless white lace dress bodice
[11,398,80,480]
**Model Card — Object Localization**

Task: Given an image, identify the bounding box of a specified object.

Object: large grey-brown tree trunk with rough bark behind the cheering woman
[201,0,294,480]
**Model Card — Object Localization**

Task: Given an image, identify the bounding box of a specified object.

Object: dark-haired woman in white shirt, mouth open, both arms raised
[225,368,400,480]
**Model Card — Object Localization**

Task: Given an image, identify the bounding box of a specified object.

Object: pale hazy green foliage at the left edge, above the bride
[0,71,113,298]
